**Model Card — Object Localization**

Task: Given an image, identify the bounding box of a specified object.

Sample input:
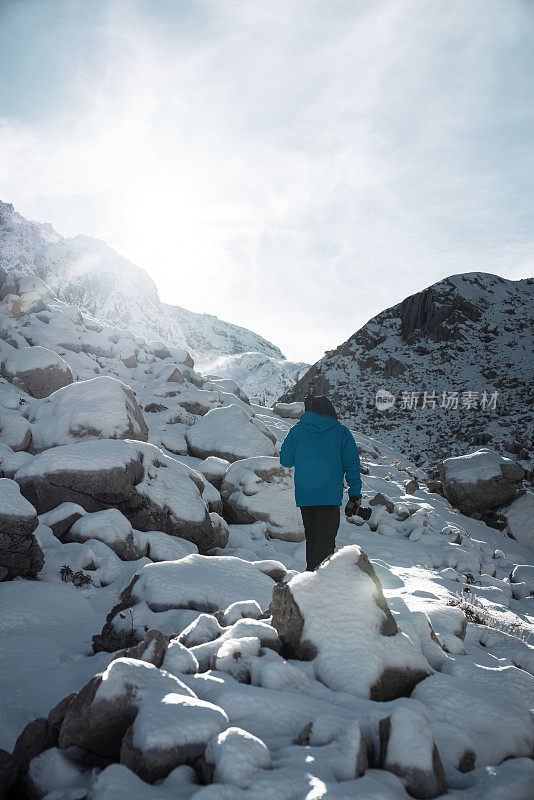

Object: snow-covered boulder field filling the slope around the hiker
[0,264,534,800]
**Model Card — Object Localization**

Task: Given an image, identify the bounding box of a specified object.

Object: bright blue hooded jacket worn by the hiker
[280,411,362,507]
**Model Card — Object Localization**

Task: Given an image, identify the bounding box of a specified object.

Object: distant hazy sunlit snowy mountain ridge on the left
[0,202,303,402]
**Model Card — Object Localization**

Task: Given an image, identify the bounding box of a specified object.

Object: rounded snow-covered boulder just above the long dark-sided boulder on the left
[28,375,148,453]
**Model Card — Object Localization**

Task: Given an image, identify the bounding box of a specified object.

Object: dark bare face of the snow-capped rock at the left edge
[0,500,44,580]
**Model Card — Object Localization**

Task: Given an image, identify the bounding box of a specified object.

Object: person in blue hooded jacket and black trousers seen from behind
[280,395,362,571]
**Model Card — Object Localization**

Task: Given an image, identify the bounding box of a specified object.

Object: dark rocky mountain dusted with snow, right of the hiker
[280,272,534,464]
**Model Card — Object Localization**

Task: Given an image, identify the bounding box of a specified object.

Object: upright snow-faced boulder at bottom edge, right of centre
[379,705,447,800]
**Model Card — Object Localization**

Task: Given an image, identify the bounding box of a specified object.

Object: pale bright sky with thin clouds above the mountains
[0,0,534,362]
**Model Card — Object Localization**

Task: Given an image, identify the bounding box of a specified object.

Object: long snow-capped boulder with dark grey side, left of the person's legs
[16,439,221,552]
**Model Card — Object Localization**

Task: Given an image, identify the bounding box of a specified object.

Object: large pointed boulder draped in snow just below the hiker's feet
[269,545,432,701]
